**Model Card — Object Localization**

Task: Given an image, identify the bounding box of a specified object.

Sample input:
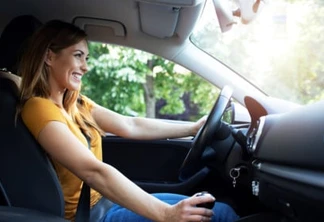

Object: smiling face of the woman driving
[46,40,89,92]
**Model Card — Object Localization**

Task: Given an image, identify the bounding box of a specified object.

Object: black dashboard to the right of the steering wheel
[245,97,324,221]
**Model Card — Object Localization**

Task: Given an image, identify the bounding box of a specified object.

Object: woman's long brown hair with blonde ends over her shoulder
[17,20,104,138]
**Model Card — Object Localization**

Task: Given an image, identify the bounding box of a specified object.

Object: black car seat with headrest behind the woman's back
[0,16,64,221]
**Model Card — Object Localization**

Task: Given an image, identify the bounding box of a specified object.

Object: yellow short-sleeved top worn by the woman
[21,96,102,220]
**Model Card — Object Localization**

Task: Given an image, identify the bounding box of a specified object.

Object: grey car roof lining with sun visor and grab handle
[0,0,205,59]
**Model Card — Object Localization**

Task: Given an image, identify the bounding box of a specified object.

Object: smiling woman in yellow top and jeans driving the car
[18,20,237,222]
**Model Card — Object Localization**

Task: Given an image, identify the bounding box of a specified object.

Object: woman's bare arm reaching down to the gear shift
[38,121,213,221]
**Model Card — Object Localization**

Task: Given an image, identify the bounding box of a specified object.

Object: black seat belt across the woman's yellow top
[75,133,91,222]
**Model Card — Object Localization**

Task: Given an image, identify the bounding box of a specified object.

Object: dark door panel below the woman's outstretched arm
[102,136,192,183]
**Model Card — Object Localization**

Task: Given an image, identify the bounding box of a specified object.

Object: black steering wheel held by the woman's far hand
[179,86,233,180]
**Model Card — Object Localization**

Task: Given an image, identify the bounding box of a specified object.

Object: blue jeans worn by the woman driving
[102,193,239,222]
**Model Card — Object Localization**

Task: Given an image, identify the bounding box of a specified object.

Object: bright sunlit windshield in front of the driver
[191,0,324,104]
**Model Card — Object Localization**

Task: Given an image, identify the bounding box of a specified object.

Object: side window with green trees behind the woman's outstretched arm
[82,42,219,121]
